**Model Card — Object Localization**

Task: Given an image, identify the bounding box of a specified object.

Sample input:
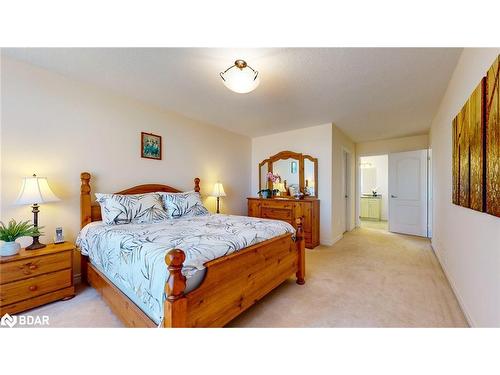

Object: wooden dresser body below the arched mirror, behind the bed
[247,198,319,249]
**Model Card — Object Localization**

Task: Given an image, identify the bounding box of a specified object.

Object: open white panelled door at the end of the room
[389,150,427,237]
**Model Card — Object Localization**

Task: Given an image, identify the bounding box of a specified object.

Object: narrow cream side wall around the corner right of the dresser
[331,126,356,242]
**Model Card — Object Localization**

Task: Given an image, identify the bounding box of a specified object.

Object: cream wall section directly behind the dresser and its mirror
[251,124,333,245]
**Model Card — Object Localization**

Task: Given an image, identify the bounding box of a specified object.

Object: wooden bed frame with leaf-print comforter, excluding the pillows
[79,172,305,327]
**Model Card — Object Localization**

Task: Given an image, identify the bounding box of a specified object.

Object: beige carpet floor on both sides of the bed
[16,228,467,327]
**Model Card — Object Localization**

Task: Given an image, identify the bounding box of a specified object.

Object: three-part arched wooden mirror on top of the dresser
[259,151,318,197]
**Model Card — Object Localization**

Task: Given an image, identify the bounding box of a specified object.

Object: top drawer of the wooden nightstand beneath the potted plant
[0,251,72,284]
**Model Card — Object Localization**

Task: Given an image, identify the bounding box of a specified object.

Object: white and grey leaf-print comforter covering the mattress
[76,214,295,324]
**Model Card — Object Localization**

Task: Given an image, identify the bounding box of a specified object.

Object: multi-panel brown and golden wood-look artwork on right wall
[452,57,500,217]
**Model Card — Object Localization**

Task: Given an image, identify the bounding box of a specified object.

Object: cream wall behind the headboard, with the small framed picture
[0,57,251,276]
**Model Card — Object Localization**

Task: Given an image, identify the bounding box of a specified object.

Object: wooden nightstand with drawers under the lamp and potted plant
[0,242,75,316]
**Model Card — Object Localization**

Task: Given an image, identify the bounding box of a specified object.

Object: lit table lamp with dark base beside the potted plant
[16,174,60,250]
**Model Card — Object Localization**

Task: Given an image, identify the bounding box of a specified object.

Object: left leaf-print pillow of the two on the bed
[95,193,168,224]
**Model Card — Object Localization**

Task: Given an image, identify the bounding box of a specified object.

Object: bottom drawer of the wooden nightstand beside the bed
[0,269,72,306]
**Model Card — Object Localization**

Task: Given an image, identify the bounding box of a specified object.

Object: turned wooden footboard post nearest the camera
[163,249,187,328]
